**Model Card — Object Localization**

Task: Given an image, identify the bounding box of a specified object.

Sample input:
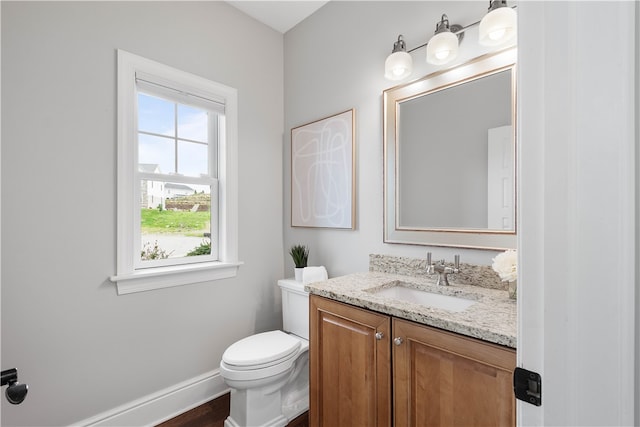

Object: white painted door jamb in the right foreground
[517,2,640,425]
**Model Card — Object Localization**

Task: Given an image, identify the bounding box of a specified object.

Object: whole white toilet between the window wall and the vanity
[220,280,309,427]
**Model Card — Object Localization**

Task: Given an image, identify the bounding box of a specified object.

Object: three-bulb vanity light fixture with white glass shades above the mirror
[384,0,518,80]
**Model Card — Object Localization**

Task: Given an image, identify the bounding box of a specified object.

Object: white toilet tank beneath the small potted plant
[278,279,309,340]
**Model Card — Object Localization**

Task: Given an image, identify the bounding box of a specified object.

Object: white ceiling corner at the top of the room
[227,0,327,34]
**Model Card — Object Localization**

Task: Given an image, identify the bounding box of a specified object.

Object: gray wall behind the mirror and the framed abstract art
[284,1,496,276]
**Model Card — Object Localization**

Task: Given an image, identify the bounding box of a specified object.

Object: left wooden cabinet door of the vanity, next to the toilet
[309,295,391,427]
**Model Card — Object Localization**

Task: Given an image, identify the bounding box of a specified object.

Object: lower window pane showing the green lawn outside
[140,180,211,261]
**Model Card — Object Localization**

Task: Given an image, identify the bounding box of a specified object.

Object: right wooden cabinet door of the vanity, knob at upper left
[393,319,516,426]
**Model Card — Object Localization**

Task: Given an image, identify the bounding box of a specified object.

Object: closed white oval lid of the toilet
[222,331,301,370]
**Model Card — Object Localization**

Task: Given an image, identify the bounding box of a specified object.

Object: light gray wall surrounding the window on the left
[1,1,284,426]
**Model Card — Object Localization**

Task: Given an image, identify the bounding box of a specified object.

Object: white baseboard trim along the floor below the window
[72,369,229,427]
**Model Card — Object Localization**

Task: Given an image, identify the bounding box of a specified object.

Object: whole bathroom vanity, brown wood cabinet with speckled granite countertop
[305,258,516,426]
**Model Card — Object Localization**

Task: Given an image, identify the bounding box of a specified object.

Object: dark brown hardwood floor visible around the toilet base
[156,393,309,427]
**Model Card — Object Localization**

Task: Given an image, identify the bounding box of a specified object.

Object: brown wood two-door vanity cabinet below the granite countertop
[309,295,516,427]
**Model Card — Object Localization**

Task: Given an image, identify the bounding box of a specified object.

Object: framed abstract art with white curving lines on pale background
[291,109,355,229]
